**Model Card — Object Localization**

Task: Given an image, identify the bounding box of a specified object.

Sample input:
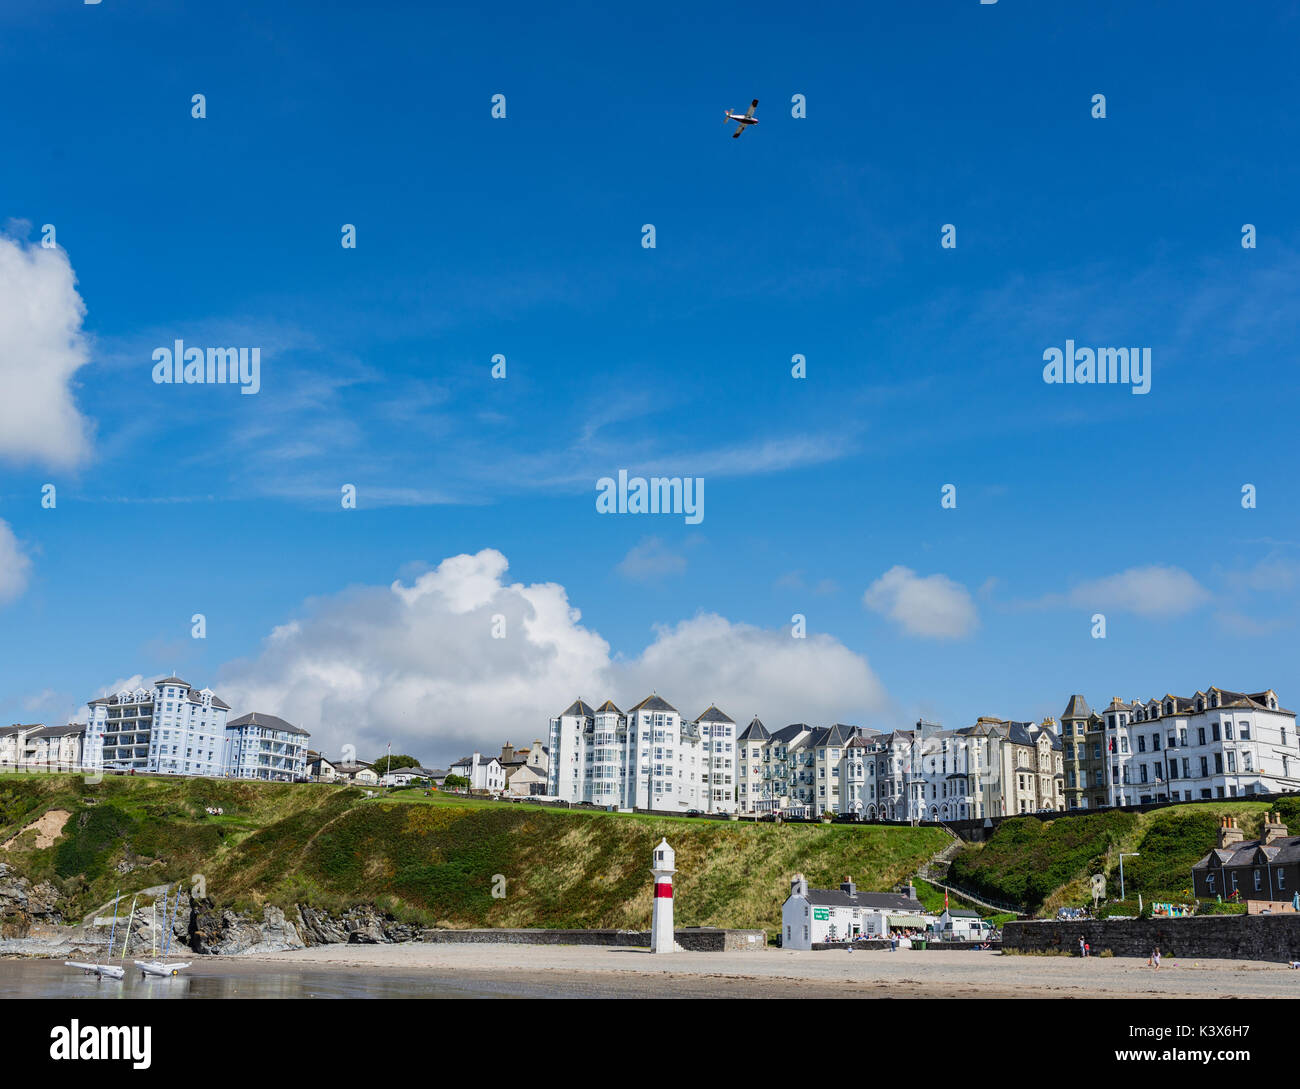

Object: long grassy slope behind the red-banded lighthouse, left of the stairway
[0,775,946,928]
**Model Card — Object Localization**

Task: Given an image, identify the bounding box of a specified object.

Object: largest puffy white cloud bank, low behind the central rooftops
[216,548,887,762]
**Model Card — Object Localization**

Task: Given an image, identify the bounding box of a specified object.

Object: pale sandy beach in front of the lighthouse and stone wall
[231,943,1300,998]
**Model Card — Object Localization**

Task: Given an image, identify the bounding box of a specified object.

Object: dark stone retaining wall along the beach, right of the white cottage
[1002,915,1300,960]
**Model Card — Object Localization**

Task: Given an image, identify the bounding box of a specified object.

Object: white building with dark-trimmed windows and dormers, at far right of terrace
[1102,686,1300,806]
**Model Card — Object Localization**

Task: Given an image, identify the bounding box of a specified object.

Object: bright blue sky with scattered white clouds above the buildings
[0,0,1300,762]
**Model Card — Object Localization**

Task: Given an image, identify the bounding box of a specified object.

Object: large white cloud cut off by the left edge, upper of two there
[0,235,90,469]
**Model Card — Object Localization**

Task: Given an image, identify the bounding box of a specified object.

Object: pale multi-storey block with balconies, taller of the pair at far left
[85,677,230,776]
